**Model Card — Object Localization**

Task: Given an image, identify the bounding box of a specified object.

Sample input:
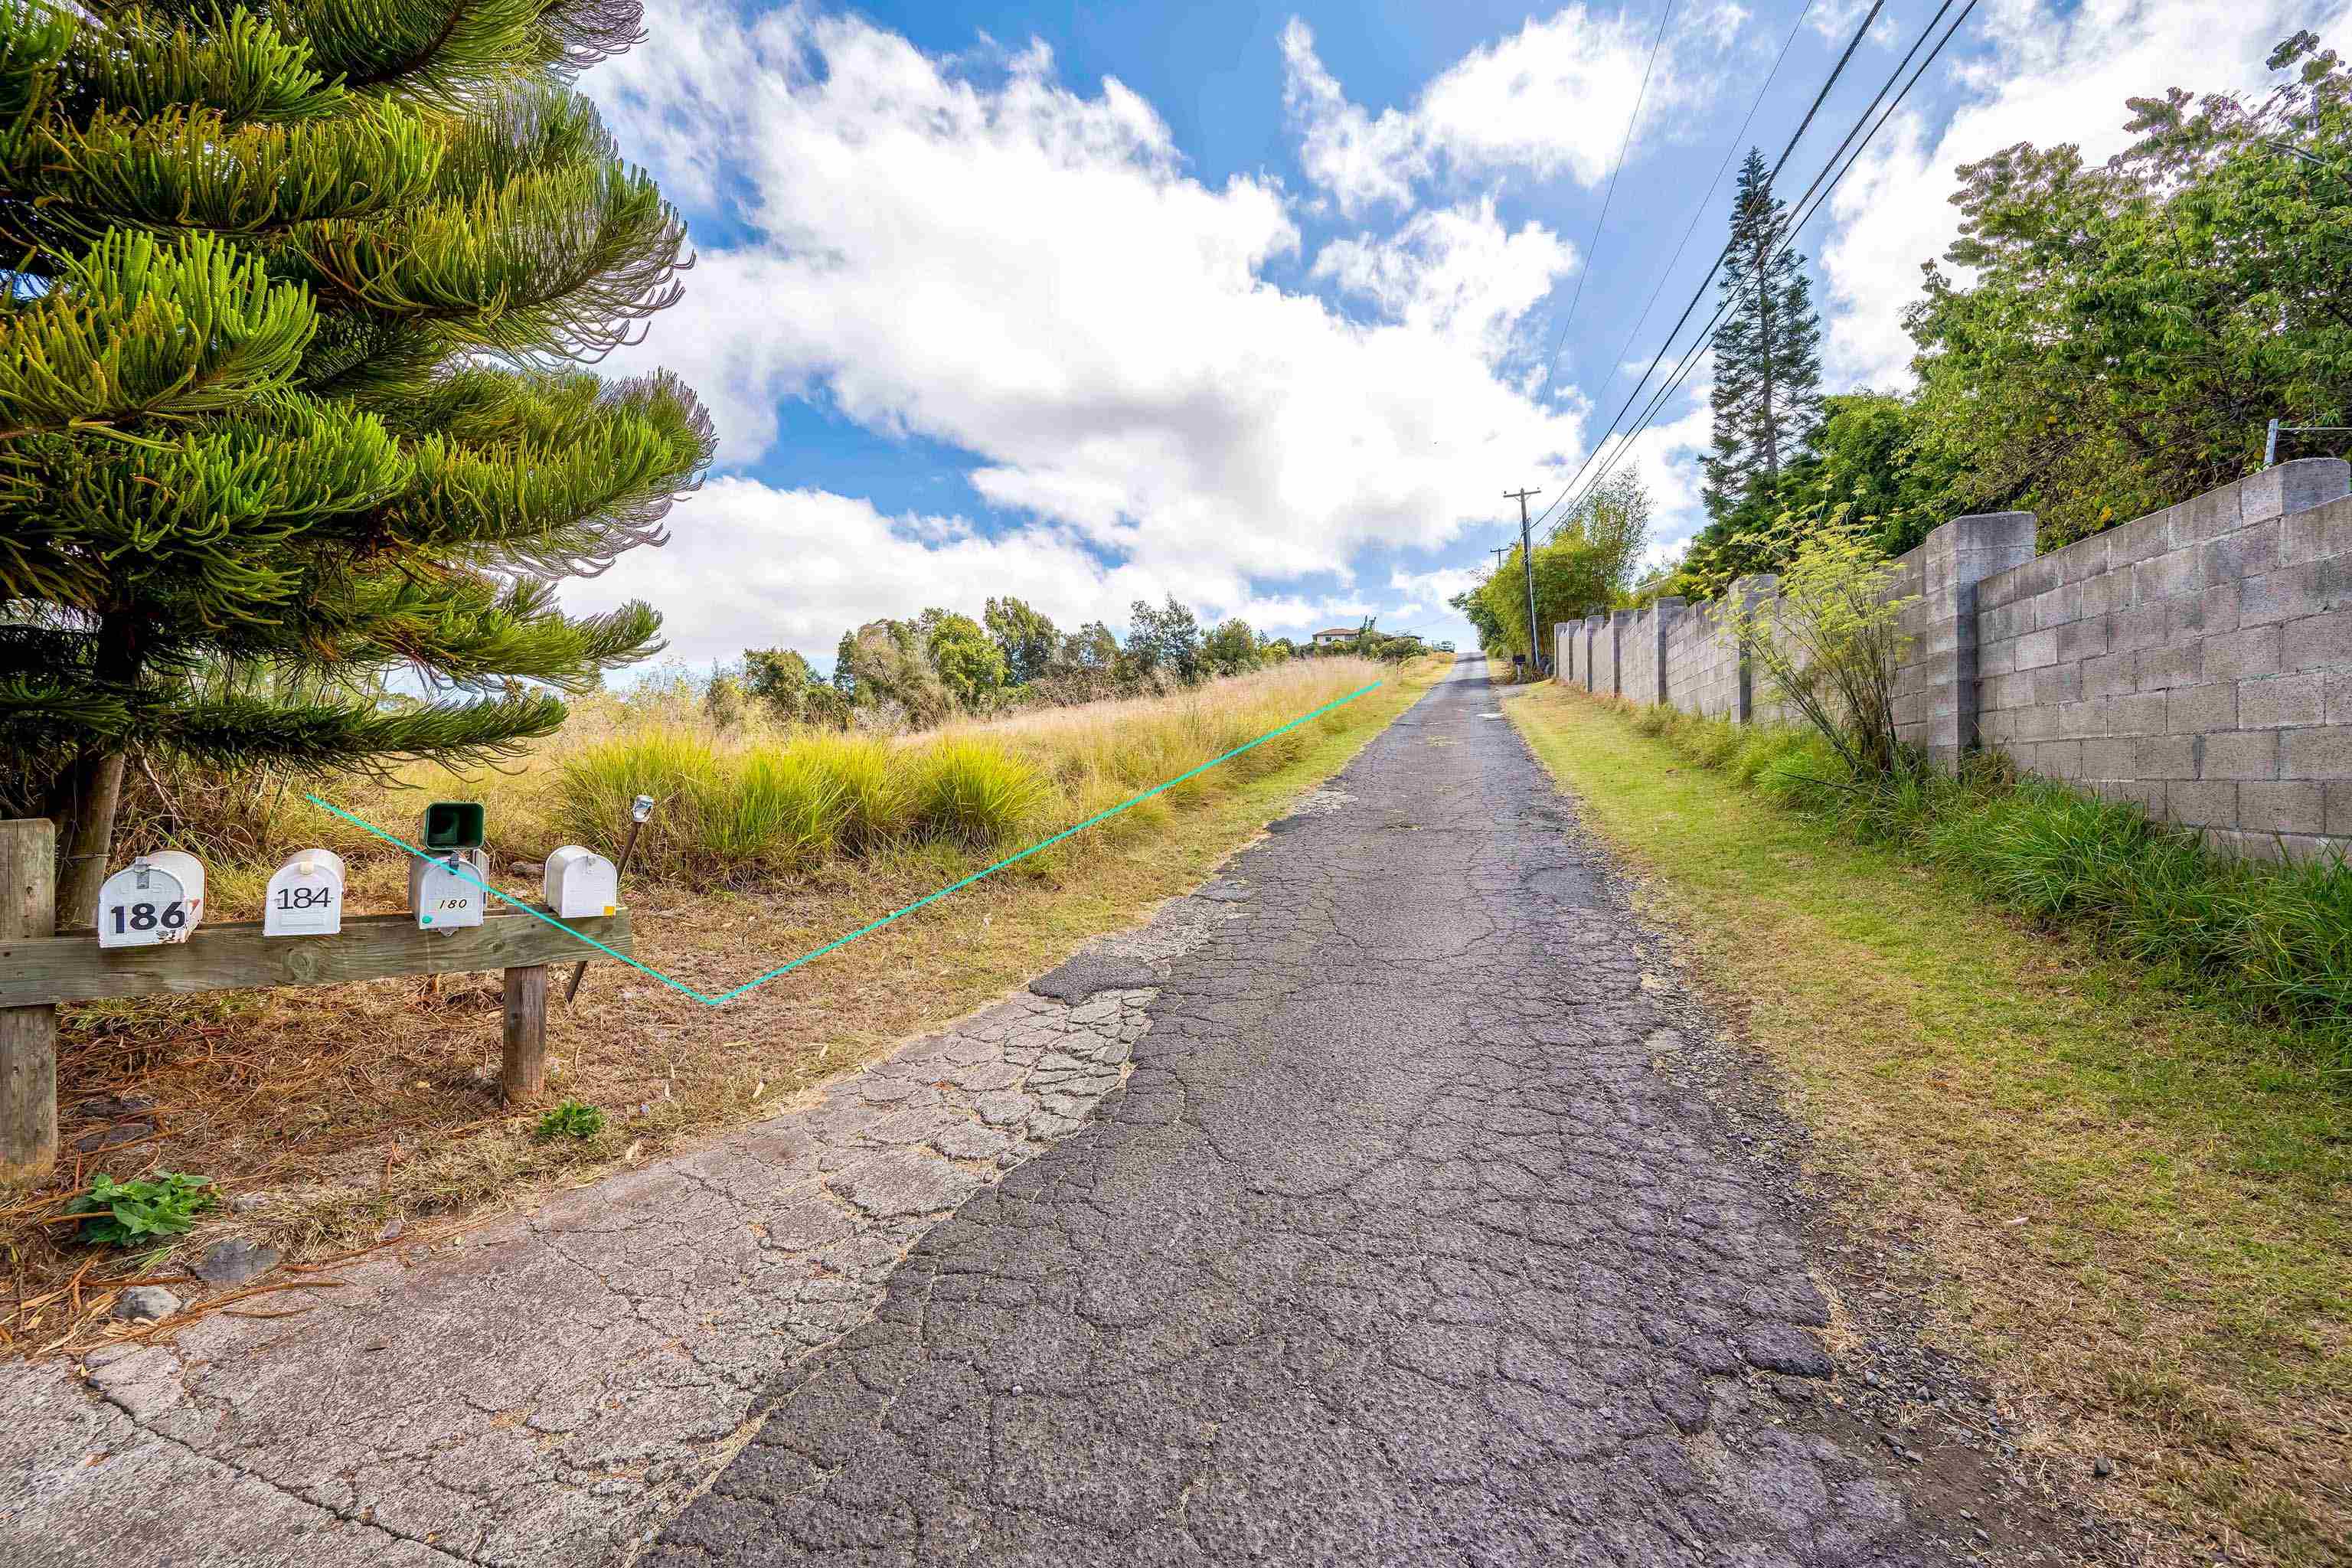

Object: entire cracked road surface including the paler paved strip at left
[0,661,2041,1568]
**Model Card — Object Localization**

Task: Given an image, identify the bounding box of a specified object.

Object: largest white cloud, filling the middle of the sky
[588,0,1580,637]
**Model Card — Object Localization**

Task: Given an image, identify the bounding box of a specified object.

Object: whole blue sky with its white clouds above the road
[567,0,2341,663]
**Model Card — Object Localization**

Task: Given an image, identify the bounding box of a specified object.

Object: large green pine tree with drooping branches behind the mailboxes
[0,0,713,926]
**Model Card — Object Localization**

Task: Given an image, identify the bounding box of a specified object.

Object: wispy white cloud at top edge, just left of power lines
[1282,5,1703,214]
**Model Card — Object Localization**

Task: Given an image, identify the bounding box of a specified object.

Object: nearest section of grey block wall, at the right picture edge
[1975,459,2352,856]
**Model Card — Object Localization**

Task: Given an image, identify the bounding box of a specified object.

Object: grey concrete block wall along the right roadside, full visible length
[1553,459,2352,858]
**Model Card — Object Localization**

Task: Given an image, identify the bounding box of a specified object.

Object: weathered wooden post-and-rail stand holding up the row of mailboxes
[0,818,632,1187]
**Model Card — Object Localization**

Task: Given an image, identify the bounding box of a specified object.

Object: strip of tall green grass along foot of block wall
[1613,703,2352,1062]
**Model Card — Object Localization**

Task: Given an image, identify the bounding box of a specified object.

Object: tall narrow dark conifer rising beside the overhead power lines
[1705,148,1821,520]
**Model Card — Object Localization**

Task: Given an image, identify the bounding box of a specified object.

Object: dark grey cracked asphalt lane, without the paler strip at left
[640,661,1957,1568]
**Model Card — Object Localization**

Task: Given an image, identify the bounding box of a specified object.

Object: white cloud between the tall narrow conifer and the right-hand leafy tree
[1821,0,2345,388]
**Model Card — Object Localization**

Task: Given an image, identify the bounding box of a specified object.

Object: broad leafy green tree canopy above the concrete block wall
[1658,33,2352,597]
